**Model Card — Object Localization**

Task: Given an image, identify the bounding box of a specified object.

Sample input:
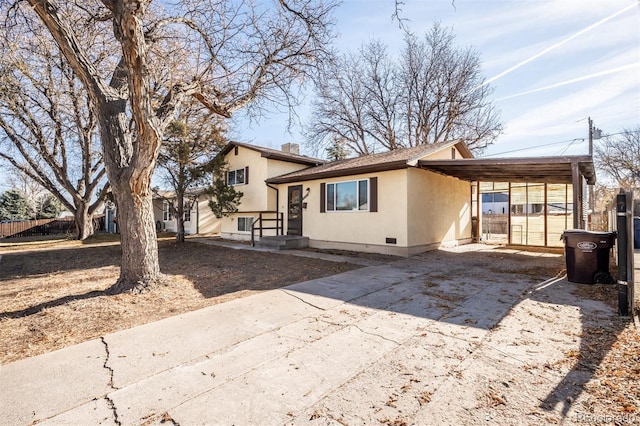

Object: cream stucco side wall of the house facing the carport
[407,169,471,247]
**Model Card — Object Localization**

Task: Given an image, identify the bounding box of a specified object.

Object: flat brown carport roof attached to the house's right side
[418,155,596,185]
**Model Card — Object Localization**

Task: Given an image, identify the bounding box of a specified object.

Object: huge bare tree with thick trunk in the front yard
[0,0,334,291]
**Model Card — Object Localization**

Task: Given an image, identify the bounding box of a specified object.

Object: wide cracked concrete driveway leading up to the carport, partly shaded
[0,245,615,425]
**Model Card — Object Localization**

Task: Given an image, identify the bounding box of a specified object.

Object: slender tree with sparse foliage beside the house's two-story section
[157,105,225,242]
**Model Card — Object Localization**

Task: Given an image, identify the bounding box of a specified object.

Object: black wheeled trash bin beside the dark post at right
[562,229,617,284]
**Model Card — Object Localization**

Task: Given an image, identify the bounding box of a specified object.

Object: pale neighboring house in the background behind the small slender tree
[153,189,221,235]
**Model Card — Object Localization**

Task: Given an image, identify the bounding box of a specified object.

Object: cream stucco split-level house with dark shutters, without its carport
[222,141,472,256]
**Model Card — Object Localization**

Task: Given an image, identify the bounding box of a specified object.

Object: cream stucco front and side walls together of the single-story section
[272,168,471,255]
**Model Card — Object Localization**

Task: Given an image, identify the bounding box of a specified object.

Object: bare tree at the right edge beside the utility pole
[594,127,640,189]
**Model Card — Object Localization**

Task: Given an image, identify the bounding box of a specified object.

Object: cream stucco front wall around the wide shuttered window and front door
[279,170,407,251]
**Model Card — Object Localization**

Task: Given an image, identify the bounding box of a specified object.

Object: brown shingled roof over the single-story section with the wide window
[267,140,473,183]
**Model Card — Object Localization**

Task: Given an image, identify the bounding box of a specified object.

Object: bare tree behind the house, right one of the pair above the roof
[401,23,502,150]
